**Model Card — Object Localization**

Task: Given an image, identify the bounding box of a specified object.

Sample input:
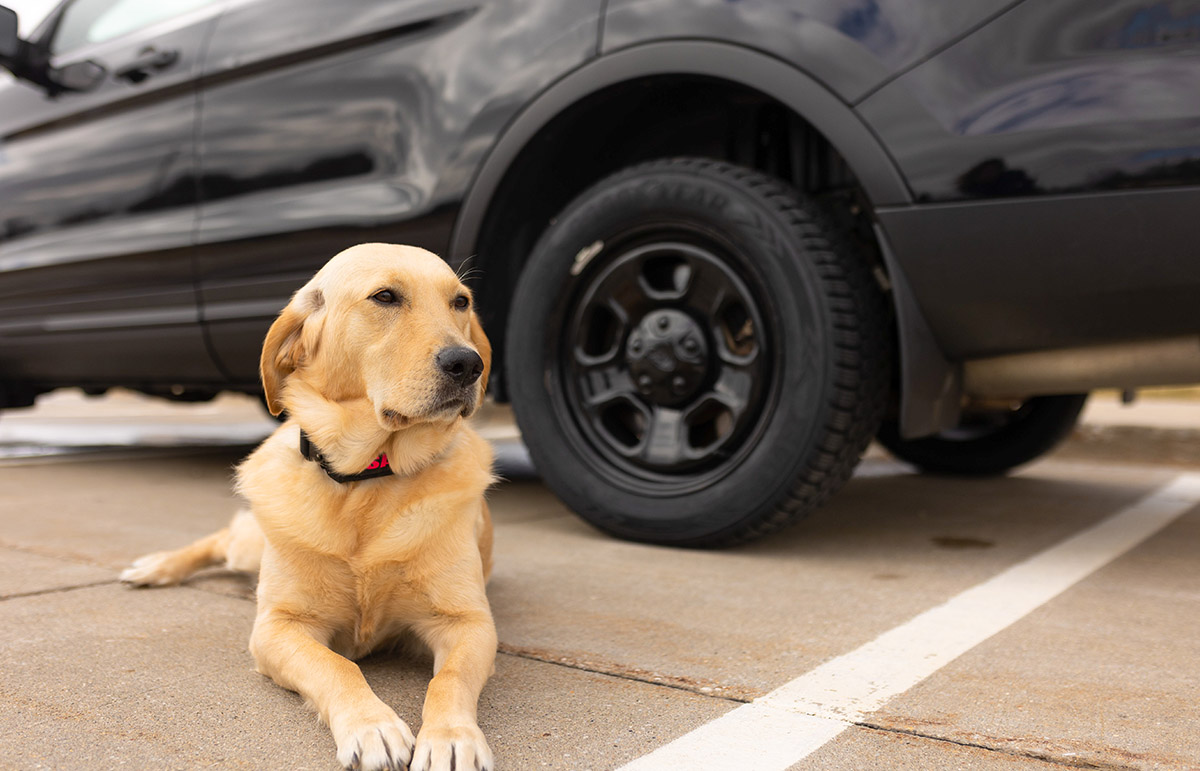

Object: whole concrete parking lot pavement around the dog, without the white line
[0,395,1200,770]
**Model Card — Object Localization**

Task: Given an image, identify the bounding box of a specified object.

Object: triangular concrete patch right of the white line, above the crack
[872,504,1200,769]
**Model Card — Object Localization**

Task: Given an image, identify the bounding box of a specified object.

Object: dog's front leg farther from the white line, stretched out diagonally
[250,611,414,771]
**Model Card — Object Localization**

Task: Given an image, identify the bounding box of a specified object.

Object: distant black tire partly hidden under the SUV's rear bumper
[877,394,1087,477]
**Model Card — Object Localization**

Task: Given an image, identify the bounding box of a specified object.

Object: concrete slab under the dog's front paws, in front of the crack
[0,585,728,770]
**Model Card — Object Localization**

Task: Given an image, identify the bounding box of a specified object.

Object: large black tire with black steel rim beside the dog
[505,159,892,546]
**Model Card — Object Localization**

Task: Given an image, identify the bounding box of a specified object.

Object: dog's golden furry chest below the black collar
[242,444,487,658]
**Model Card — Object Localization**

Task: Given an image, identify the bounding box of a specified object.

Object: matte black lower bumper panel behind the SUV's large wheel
[878,189,1200,360]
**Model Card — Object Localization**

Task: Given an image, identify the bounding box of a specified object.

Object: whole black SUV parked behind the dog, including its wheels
[0,0,1200,545]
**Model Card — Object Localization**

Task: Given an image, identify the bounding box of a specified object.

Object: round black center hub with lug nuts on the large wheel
[625,309,709,406]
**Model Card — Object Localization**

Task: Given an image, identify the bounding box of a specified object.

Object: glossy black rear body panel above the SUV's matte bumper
[859,0,1200,202]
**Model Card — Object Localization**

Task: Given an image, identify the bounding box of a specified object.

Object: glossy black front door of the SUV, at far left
[0,0,220,387]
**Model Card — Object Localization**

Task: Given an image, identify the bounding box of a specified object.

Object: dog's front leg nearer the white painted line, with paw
[412,609,497,771]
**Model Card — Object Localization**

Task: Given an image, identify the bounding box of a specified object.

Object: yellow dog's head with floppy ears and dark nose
[260,244,492,430]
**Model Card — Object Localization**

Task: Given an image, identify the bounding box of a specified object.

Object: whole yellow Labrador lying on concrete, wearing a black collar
[121,244,496,771]
